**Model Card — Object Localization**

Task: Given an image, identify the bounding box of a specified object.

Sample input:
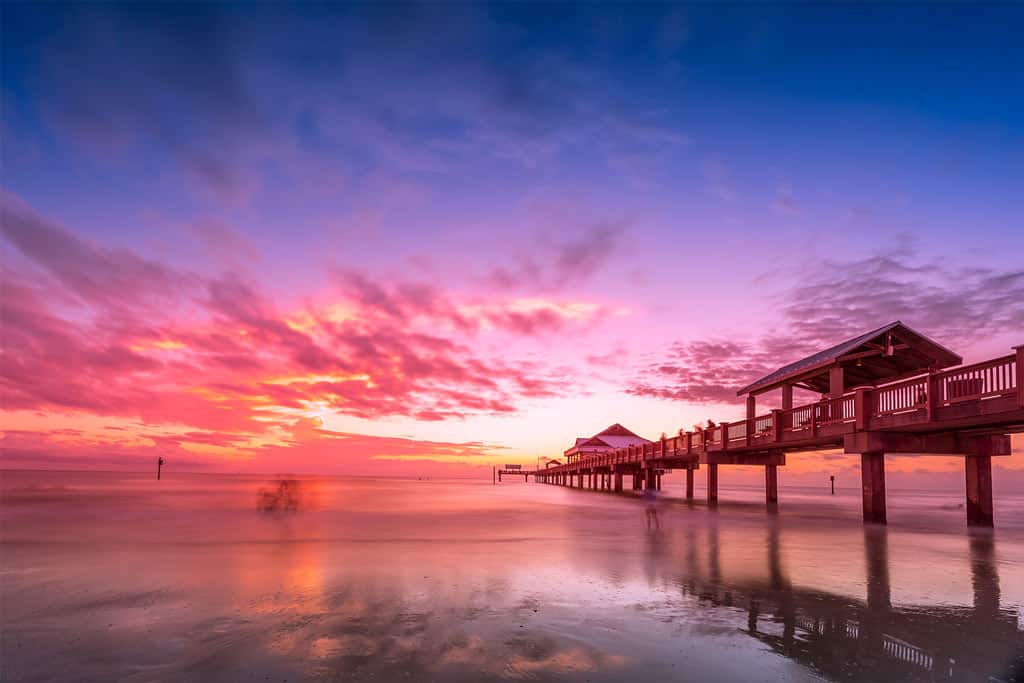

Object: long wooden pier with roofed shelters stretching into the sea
[516,322,1024,526]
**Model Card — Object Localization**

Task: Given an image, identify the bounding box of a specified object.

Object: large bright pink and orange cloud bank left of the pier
[0,196,614,471]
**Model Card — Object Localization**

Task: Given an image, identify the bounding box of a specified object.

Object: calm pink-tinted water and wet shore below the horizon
[0,471,1024,682]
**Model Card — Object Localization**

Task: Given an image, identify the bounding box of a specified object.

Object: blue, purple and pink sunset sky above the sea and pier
[0,3,1024,484]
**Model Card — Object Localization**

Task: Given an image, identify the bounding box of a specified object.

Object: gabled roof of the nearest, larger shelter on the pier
[736,321,963,395]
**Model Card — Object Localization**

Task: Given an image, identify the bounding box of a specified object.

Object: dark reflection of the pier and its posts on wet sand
[645,524,1024,681]
